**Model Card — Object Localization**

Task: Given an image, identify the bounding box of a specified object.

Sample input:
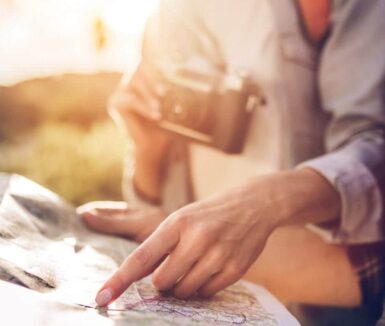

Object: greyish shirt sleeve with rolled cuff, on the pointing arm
[300,0,385,244]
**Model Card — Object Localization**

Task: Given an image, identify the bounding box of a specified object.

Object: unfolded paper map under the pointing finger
[0,174,299,326]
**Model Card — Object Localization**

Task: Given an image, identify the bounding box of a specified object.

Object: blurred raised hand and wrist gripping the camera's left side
[108,62,170,199]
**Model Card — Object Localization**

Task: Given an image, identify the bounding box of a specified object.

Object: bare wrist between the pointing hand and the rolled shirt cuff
[240,168,341,228]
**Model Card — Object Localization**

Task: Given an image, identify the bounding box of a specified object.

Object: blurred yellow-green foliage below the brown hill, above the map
[0,121,127,205]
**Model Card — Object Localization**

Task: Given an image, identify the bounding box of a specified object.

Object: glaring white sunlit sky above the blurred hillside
[0,0,159,84]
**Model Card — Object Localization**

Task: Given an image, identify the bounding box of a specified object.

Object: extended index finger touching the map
[95,225,179,307]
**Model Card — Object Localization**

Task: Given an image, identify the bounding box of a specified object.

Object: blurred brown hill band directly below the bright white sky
[0,73,120,142]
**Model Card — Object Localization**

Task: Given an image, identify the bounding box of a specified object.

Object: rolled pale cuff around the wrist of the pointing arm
[297,152,384,244]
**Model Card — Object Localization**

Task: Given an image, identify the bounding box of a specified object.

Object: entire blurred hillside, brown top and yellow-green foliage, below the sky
[0,73,131,205]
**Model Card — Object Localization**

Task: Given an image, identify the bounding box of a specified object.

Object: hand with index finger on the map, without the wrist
[92,180,273,306]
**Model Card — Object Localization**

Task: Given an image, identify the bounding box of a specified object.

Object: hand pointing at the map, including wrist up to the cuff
[91,169,339,306]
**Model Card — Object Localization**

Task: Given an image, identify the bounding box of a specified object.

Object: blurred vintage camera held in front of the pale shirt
[159,68,264,154]
